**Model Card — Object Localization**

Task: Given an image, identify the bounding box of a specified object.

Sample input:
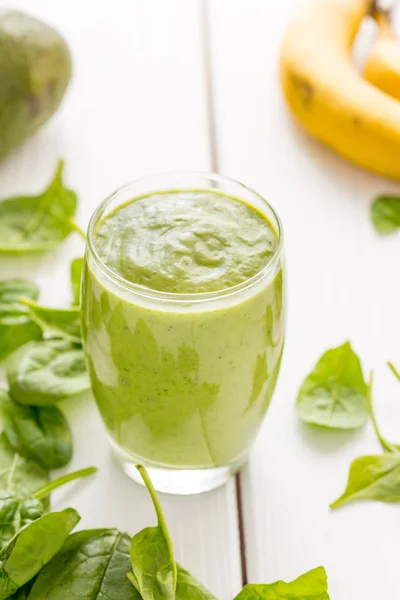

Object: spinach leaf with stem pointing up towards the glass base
[130,466,177,600]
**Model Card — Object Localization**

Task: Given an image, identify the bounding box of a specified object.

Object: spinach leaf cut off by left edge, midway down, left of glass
[0,279,42,360]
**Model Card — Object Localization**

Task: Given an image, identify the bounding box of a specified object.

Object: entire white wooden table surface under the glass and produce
[0,0,400,600]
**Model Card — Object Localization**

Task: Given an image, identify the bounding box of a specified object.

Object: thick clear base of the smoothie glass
[110,440,245,496]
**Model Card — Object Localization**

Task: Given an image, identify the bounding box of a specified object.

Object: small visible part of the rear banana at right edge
[364,12,400,99]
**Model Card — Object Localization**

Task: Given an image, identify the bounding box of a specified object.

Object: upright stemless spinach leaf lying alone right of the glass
[297,342,368,429]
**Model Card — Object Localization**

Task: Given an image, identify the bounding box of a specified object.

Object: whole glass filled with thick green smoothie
[82,173,286,494]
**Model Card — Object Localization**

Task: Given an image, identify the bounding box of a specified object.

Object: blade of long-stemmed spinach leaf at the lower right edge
[331,452,400,508]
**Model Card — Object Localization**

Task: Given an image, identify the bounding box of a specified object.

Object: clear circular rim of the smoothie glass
[87,171,283,303]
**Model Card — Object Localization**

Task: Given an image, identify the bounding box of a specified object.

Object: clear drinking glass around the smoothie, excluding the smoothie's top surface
[82,173,286,494]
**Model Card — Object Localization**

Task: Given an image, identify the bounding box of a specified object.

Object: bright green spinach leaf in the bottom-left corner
[0,508,80,600]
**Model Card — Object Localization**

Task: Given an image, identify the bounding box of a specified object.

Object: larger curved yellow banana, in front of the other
[281,0,400,179]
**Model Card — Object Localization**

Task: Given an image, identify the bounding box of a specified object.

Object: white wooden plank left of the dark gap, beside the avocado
[0,0,241,600]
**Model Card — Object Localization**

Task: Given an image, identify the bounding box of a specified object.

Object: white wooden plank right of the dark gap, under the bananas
[209,0,400,600]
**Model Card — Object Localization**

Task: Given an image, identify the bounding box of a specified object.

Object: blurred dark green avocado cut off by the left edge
[0,10,72,160]
